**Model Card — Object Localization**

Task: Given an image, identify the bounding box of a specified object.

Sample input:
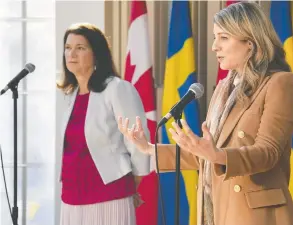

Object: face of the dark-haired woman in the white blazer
[64,34,95,77]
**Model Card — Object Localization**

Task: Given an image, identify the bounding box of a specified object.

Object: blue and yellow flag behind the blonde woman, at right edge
[271,1,293,196]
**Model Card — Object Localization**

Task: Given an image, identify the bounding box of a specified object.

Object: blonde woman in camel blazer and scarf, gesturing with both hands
[119,2,293,225]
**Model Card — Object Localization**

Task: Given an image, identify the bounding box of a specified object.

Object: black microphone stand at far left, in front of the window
[10,83,18,225]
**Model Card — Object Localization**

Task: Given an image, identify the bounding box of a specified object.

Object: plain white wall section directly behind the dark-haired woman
[55,0,105,224]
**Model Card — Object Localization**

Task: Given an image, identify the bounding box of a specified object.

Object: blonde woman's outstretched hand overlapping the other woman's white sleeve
[118,116,154,155]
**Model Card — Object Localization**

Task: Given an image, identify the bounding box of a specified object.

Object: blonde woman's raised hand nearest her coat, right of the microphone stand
[169,120,226,164]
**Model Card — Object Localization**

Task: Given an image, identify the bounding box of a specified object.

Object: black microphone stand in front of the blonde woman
[173,111,182,225]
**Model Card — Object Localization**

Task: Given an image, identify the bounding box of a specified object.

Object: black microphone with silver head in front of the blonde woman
[158,83,204,127]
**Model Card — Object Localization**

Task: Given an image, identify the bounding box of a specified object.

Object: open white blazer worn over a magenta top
[59,77,150,184]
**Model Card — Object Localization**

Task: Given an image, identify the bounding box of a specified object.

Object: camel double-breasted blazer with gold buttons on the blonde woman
[158,72,293,225]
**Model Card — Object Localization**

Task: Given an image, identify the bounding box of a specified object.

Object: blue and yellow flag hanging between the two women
[158,1,200,225]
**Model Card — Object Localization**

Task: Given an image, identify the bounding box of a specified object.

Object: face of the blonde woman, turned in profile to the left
[212,24,252,73]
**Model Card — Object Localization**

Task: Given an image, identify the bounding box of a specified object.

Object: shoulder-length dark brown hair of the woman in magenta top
[57,23,119,94]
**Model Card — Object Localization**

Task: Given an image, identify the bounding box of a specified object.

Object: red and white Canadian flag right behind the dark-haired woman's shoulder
[124,0,158,225]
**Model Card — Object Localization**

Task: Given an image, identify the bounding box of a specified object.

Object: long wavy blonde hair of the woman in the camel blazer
[214,2,290,102]
